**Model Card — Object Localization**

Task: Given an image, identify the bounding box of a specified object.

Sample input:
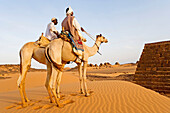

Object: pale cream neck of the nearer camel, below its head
[88,41,101,57]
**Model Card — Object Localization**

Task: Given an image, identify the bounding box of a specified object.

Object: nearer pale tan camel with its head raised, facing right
[45,34,108,104]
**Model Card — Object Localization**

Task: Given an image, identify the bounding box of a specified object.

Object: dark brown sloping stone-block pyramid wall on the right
[134,41,170,95]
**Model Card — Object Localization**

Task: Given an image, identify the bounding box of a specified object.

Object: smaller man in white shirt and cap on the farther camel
[45,18,59,41]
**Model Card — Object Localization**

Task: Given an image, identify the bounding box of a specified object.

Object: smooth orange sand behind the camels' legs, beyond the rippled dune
[0,72,79,92]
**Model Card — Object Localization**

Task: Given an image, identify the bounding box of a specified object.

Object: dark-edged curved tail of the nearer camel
[45,46,63,71]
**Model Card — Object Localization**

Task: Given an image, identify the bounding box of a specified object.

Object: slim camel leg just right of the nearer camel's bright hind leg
[56,63,65,98]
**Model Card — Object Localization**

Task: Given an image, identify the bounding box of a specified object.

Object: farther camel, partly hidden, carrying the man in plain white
[17,33,107,107]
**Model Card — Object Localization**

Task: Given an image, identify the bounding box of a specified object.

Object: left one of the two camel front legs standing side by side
[78,63,84,94]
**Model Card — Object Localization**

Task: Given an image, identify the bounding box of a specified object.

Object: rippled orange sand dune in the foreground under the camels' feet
[0,80,170,113]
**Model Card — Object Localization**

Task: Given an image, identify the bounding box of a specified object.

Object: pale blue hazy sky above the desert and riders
[0,0,170,68]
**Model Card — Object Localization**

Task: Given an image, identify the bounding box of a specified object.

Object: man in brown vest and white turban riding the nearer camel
[62,6,86,62]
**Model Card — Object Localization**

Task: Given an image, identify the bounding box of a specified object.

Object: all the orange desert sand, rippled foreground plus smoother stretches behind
[0,67,170,113]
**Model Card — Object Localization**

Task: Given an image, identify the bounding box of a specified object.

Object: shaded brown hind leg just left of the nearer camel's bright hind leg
[45,62,54,103]
